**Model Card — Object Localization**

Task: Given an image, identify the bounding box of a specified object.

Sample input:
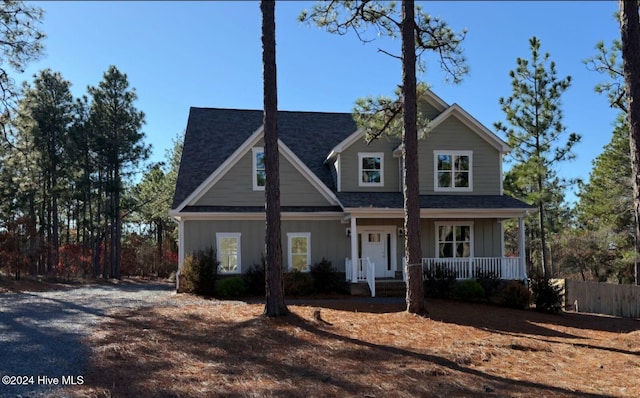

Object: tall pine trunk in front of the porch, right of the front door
[402,0,427,315]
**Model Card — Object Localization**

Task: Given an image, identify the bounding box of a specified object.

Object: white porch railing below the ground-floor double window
[402,257,527,280]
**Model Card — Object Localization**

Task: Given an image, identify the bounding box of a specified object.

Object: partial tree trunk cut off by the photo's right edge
[619,0,640,284]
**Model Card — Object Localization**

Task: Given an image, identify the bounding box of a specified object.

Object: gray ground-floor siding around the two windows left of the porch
[184,220,351,272]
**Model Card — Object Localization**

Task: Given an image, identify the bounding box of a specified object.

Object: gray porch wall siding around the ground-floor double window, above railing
[420,218,502,258]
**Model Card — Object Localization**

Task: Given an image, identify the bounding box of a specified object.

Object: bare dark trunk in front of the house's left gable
[260,0,289,316]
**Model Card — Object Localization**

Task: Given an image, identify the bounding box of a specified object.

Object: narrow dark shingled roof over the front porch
[336,192,534,211]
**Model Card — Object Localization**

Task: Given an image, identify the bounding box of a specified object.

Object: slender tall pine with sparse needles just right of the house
[495,36,580,278]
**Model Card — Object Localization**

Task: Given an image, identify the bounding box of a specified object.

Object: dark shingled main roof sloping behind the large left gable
[171,107,357,209]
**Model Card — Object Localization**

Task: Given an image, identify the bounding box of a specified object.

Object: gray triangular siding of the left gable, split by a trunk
[195,140,331,206]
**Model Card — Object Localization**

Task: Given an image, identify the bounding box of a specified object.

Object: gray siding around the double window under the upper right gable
[418,116,502,195]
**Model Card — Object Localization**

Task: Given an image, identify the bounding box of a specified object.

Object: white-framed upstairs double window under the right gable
[433,151,473,192]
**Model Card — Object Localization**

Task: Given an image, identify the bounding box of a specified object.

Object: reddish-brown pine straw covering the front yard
[67,295,640,397]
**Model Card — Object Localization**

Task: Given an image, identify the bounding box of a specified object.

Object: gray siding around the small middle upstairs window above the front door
[340,138,400,192]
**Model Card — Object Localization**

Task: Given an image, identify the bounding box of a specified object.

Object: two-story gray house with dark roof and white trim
[170,91,532,294]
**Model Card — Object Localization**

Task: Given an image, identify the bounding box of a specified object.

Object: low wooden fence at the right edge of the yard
[563,279,640,318]
